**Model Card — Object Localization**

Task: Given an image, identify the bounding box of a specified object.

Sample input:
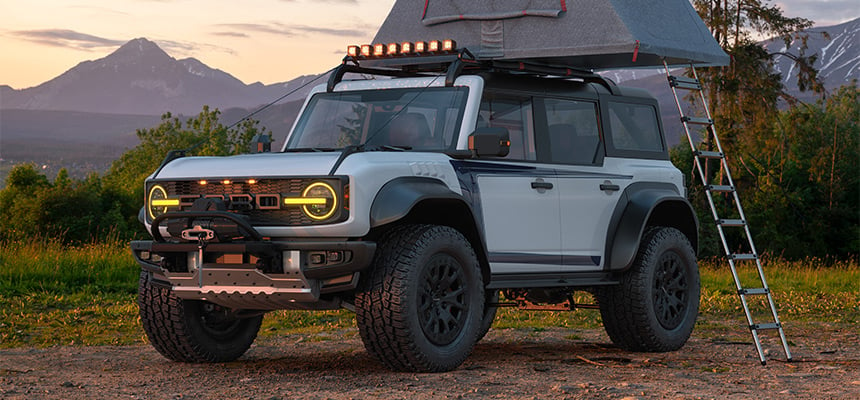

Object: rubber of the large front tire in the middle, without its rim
[355,225,484,372]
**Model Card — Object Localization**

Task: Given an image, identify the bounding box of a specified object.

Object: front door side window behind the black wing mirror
[477,93,536,160]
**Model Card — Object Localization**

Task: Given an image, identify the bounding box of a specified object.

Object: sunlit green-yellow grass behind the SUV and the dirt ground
[0,240,860,348]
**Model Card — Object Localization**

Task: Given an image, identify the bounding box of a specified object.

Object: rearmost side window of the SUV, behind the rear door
[609,102,665,153]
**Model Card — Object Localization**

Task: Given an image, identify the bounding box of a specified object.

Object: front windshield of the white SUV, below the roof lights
[287,87,468,151]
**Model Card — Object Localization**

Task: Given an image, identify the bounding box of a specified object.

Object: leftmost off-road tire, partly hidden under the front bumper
[137,271,263,363]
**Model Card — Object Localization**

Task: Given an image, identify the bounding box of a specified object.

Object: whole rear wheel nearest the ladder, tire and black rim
[596,227,700,352]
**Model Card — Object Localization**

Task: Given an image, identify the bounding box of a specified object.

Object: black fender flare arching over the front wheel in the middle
[370,177,490,284]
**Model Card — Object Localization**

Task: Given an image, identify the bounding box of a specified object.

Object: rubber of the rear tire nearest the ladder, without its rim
[596,227,700,352]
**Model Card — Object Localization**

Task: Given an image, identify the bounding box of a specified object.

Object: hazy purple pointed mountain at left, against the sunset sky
[0,38,298,115]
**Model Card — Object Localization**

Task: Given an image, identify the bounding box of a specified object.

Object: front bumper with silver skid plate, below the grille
[131,240,376,310]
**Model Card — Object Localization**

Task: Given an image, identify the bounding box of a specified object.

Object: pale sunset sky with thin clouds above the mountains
[0,0,860,89]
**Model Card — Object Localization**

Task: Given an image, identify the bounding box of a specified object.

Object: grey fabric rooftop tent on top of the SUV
[373,0,729,70]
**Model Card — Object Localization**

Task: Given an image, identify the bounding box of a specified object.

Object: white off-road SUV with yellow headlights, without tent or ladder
[132,46,699,371]
